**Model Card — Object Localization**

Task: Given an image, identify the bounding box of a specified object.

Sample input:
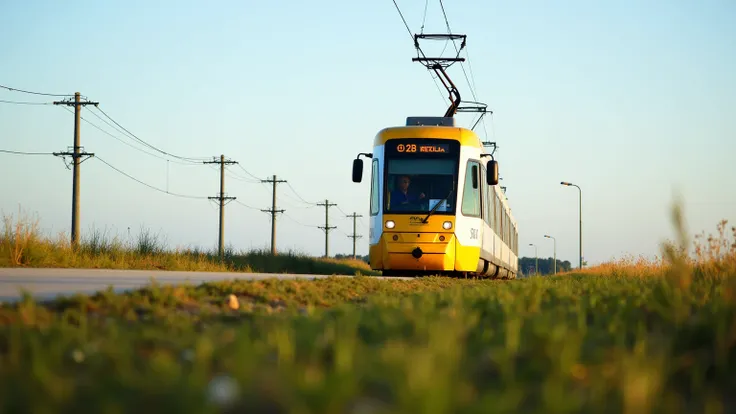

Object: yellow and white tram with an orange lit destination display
[353,116,519,279]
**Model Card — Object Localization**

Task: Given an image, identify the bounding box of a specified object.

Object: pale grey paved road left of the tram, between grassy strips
[0,268,366,302]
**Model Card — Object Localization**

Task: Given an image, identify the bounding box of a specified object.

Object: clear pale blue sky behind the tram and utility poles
[0,0,736,265]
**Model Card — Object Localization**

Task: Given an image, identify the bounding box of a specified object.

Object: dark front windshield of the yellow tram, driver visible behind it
[384,157,457,214]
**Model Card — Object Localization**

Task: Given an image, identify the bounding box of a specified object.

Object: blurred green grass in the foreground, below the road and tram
[0,201,736,414]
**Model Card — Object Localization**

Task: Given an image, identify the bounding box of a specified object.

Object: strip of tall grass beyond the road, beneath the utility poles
[0,212,380,275]
